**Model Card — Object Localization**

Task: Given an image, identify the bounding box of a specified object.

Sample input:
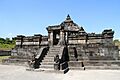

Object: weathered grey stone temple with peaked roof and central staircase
[5,15,120,70]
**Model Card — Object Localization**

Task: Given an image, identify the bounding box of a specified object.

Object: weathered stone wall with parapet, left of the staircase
[12,34,48,59]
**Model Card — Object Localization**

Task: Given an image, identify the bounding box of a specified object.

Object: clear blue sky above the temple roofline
[0,0,120,39]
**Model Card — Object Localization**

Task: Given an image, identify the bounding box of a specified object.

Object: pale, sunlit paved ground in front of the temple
[0,65,120,80]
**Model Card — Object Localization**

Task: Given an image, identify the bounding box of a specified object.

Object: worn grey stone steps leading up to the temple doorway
[40,46,64,70]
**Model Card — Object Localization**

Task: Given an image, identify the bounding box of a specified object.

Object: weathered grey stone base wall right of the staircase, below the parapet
[68,44,119,60]
